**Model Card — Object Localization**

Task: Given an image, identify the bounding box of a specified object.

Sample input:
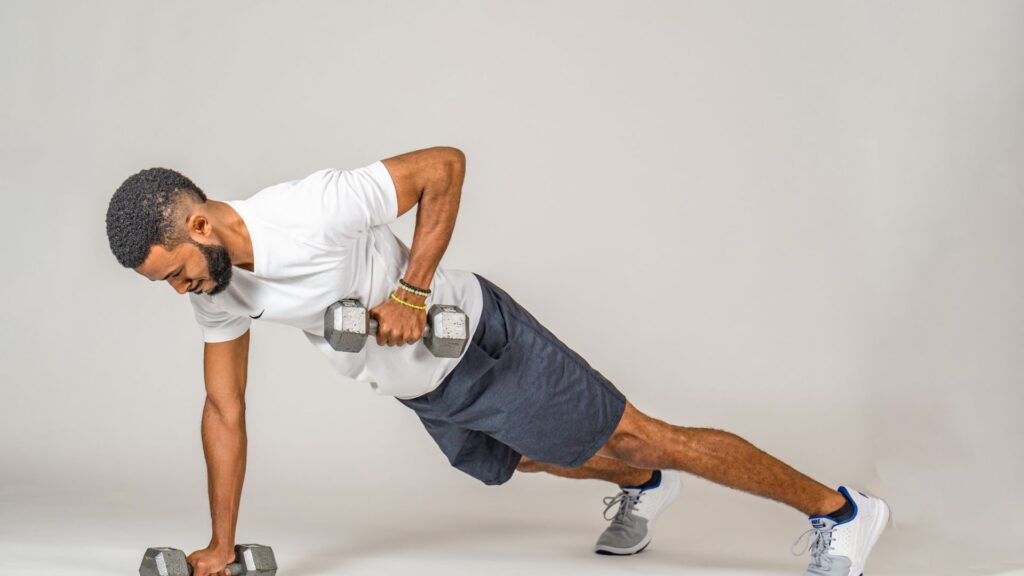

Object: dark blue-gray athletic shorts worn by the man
[399,276,626,484]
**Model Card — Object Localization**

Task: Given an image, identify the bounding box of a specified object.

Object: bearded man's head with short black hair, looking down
[106,168,231,294]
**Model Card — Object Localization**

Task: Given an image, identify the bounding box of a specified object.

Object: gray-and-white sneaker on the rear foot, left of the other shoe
[594,470,682,556]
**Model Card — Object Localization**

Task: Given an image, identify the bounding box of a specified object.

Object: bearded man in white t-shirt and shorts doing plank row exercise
[106,148,889,576]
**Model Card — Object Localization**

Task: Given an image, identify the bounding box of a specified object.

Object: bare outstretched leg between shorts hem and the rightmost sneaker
[598,404,846,516]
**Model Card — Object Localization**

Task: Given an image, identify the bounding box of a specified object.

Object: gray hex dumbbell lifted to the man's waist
[324,299,469,358]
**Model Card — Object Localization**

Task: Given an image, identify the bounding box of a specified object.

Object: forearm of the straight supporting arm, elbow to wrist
[202,400,247,548]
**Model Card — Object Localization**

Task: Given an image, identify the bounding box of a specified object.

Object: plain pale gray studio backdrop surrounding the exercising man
[0,0,1024,575]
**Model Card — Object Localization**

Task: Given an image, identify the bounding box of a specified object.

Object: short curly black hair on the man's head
[106,168,206,269]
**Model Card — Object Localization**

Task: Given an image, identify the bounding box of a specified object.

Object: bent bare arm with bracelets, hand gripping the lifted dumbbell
[370,148,466,346]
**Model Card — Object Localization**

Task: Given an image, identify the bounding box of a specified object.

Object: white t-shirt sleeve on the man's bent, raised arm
[314,162,398,242]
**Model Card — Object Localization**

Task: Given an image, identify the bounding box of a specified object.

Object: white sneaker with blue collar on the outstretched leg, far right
[793,486,889,576]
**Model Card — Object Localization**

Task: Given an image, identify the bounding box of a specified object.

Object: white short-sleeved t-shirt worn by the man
[188,162,482,398]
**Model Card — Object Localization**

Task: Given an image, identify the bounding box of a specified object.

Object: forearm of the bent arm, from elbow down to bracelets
[403,149,466,288]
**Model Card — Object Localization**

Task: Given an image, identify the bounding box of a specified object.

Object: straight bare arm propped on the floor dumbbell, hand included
[188,330,249,575]
